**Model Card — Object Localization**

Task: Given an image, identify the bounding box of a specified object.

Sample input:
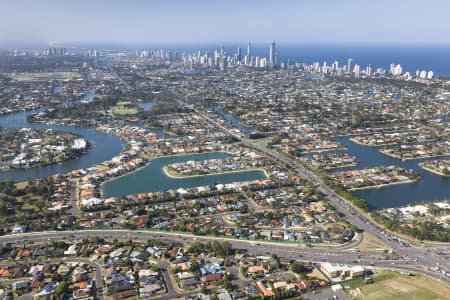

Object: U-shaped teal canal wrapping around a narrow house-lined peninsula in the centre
[102,152,266,197]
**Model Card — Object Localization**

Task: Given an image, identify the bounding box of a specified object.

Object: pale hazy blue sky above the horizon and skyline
[0,0,450,45]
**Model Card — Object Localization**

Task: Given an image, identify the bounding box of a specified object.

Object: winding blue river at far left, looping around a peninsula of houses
[0,93,122,181]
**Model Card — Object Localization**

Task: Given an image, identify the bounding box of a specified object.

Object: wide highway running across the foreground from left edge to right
[0,230,450,284]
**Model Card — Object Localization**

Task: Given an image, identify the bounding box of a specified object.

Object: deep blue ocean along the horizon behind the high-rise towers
[96,42,450,78]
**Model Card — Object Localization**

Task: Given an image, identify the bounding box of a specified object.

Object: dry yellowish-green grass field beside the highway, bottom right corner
[343,271,450,300]
